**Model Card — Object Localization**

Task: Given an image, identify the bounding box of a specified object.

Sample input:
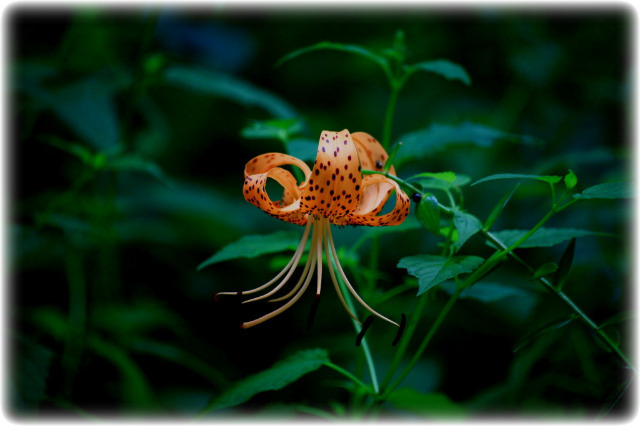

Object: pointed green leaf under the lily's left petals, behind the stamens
[198,231,300,270]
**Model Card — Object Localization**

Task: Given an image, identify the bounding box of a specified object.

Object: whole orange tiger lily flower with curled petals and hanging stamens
[216,129,410,332]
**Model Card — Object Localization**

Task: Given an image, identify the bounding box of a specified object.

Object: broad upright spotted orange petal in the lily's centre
[300,129,362,217]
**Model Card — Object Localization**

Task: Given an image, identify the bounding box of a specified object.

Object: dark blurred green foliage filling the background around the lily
[5,5,635,419]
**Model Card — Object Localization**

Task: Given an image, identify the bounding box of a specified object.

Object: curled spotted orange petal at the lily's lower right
[335,175,411,226]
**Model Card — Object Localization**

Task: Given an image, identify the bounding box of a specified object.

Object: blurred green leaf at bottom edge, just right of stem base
[387,388,466,418]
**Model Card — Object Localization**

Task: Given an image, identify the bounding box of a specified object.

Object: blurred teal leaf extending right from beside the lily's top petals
[395,121,537,165]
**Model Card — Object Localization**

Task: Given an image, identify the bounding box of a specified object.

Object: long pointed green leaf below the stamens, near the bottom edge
[201,349,329,414]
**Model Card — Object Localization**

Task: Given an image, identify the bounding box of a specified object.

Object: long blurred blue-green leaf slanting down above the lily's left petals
[164,65,297,118]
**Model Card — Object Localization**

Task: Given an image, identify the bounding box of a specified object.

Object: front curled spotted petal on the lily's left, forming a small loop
[243,166,308,225]
